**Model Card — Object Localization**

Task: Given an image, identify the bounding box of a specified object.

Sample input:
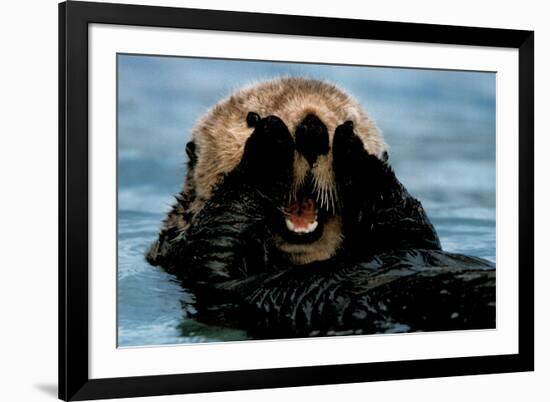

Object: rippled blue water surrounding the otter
[118,55,496,346]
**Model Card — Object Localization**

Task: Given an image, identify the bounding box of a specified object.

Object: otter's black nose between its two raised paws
[296,114,329,166]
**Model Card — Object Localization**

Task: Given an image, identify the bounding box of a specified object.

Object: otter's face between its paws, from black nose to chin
[274,113,343,264]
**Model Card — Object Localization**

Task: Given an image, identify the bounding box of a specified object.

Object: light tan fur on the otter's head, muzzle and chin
[149,78,387,264]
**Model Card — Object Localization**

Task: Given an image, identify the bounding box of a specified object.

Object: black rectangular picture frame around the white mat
[59,1,534,400]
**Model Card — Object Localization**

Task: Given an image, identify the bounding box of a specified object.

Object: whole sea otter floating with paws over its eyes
[147,78,495,338]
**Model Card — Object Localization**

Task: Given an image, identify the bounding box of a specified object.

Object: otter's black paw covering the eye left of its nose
[239,113,294,187]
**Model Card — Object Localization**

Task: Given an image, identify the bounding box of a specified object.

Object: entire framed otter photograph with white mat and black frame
[59,1,534,400]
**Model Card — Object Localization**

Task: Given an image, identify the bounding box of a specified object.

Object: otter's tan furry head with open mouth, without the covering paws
[183,78,386,264]
